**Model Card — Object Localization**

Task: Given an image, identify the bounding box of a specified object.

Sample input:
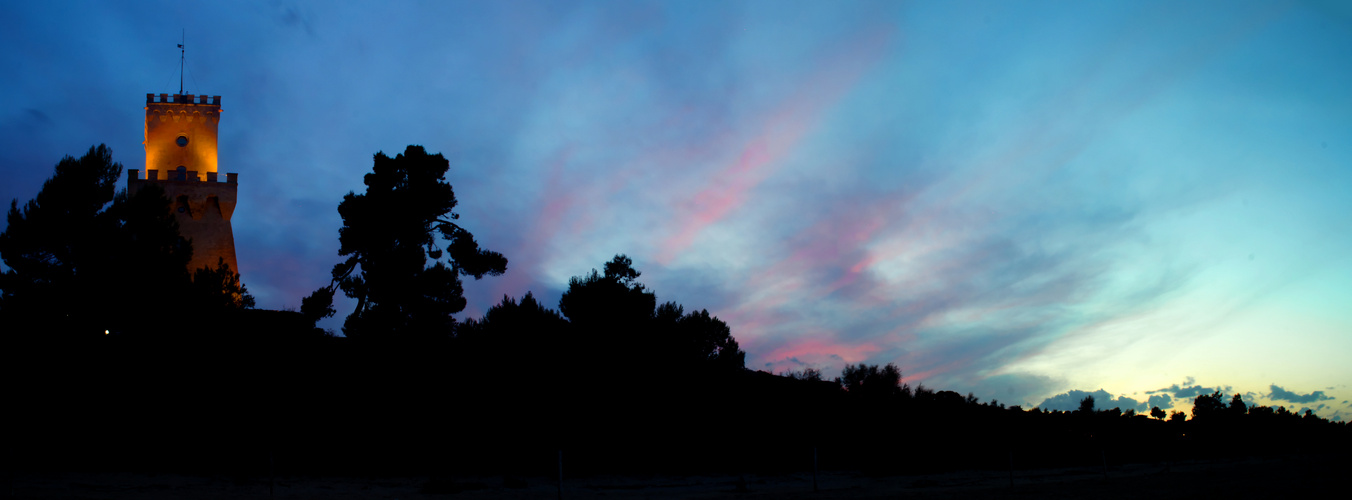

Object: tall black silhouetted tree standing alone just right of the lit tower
[320,146,507,338]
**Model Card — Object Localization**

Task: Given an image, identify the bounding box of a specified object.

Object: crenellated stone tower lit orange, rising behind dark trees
[127,93,239,273]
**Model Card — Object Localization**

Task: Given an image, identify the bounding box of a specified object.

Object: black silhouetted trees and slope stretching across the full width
[0,146,1349,476]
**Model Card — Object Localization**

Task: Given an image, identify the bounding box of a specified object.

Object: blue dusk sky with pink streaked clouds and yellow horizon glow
[0,0,1352,420]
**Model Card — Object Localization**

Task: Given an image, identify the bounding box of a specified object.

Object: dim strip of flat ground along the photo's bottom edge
[5,454,1352,500]
